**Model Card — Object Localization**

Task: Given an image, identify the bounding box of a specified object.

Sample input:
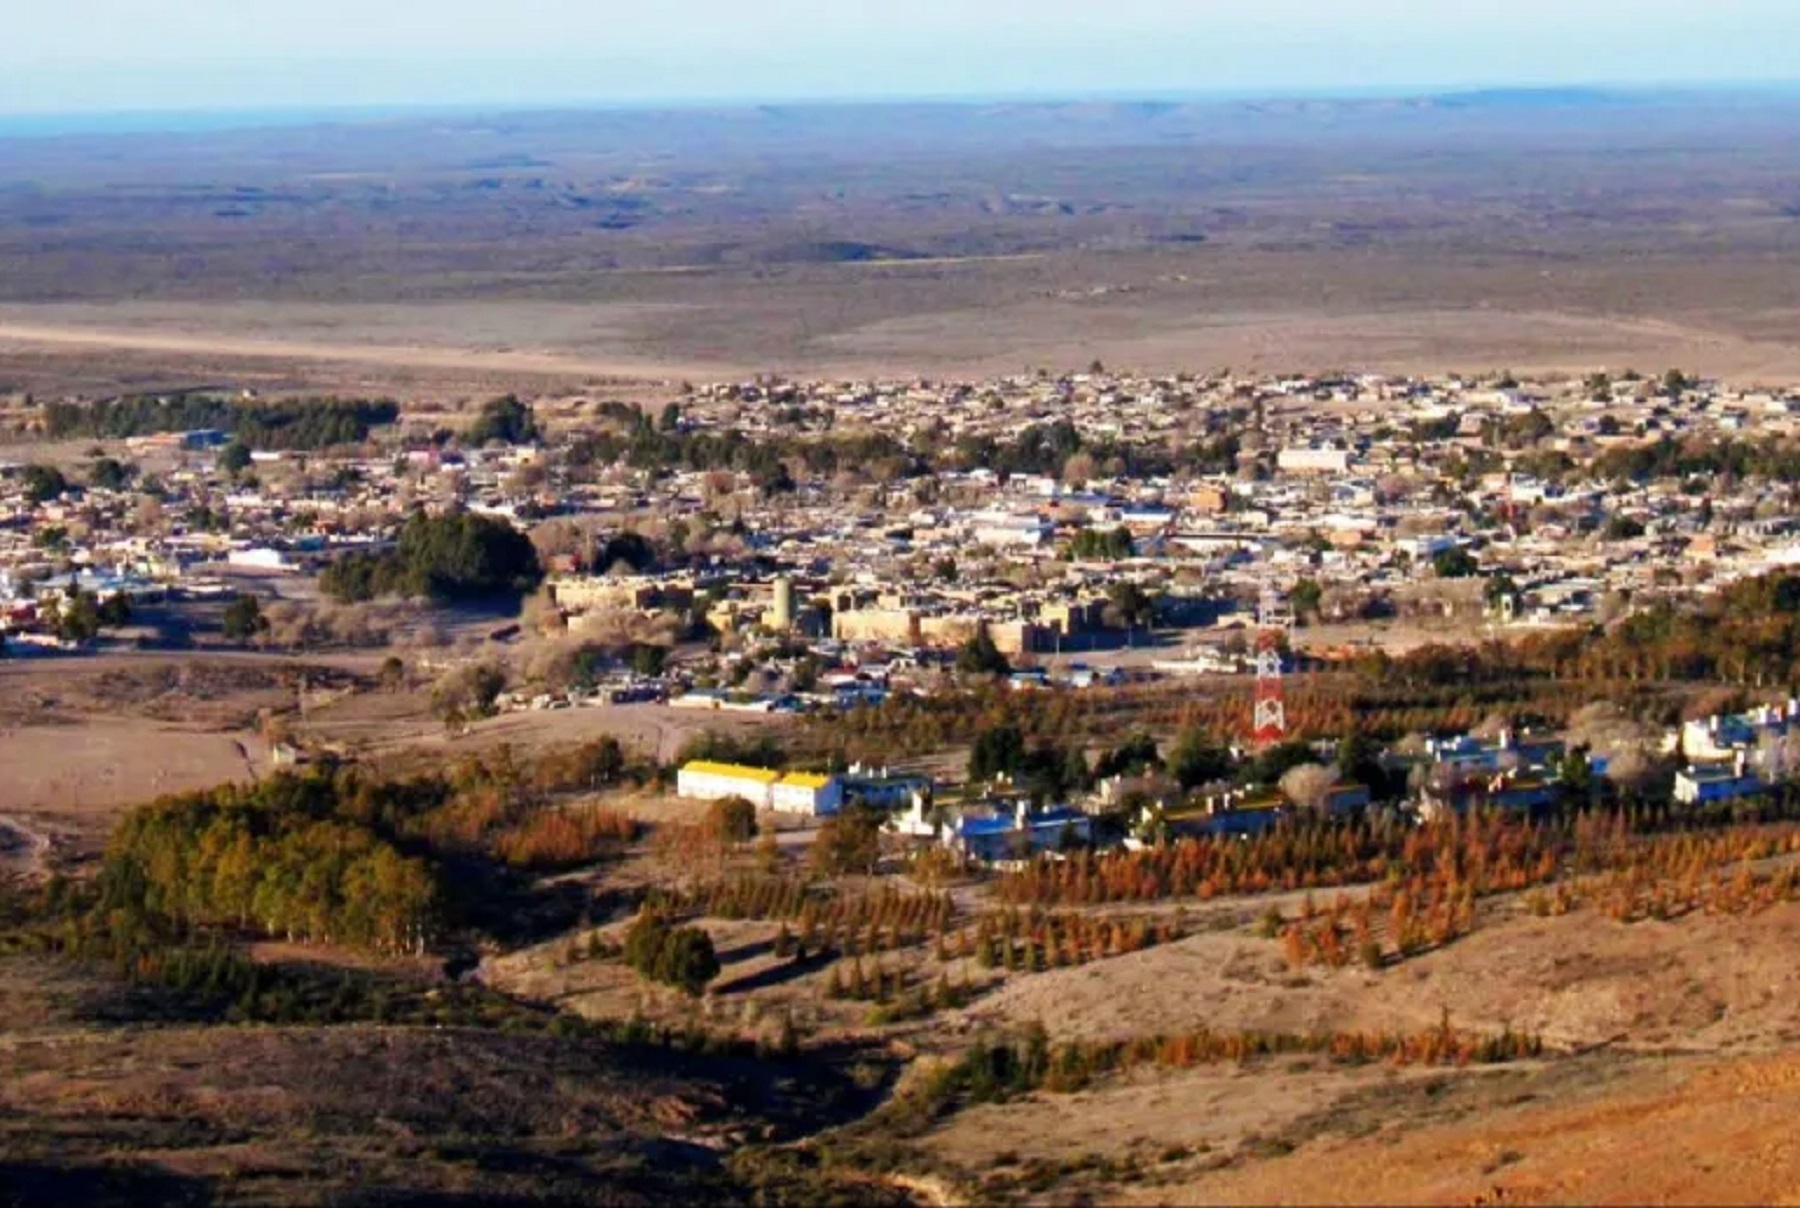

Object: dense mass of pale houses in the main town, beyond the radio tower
[10,367,1800,680]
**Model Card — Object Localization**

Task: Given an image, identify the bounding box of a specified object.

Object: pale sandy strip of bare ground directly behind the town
[10,295,1800,383]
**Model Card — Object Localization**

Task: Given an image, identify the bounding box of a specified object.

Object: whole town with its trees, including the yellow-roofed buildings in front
[0,364,1800,864]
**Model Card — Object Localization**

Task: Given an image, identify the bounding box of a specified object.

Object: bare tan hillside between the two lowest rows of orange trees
[952,897,1800,1051]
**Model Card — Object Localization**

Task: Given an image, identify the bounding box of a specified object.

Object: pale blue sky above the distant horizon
[0,0,1800,113]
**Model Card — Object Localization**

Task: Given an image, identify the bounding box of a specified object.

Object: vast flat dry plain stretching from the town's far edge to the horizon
[10,94,1800,398]
